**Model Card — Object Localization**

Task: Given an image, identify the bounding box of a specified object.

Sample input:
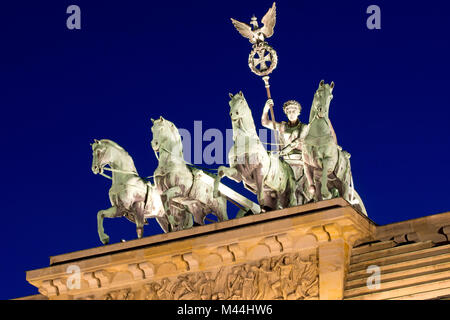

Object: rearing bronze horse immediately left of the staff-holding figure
[214,91,297,210]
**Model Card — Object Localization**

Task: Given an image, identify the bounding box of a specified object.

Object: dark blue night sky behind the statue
[0,0,450,299]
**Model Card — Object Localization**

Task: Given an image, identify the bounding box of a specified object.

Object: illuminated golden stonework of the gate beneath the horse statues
[22,198,450,300]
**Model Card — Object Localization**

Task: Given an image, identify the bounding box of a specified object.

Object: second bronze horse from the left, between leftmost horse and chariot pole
[151,117,228,232]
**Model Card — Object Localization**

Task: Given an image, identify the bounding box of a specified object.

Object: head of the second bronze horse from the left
[151,116,182,158]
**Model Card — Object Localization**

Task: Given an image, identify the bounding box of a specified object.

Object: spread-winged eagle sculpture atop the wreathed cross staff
[231,2,276,44]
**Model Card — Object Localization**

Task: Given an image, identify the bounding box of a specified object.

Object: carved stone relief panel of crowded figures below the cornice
[139,254,319,300]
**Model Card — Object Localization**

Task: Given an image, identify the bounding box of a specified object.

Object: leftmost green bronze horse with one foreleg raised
[92,139,167,244]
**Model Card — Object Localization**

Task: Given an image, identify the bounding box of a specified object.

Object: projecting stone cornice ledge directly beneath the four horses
[27,199,376,299]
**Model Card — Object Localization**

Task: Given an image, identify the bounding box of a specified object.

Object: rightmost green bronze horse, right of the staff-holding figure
[303,80,367,215]
